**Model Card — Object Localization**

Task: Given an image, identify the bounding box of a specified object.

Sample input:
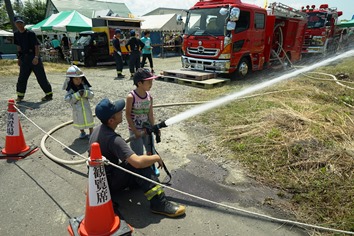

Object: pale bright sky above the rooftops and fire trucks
[108,0,354,20]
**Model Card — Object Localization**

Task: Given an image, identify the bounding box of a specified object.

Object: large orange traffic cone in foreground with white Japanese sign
[68,143,132,236]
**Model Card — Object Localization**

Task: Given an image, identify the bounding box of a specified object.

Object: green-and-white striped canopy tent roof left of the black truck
[30,10,92,32]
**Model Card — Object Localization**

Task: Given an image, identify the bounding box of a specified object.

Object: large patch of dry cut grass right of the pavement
[192,59,354,231]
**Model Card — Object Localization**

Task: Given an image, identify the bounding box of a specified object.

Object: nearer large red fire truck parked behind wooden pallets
[178,0,307,78]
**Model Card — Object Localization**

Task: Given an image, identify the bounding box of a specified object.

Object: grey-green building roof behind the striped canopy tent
[45,0,131,18]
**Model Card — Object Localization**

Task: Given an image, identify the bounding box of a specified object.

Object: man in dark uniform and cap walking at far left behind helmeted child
[14,16,53,102]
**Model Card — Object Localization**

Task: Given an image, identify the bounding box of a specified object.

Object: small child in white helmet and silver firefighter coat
[63,65,95,139]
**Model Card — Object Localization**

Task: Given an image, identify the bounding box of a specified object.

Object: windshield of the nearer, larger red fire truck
[185,8,227,36]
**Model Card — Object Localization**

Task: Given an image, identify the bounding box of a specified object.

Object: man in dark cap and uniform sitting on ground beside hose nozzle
[89,98,186,217]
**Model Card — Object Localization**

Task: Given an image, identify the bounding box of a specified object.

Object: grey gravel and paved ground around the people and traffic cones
[0,57,303,235]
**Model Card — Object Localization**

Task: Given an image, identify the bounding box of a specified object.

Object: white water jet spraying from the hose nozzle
[165,50,354,126]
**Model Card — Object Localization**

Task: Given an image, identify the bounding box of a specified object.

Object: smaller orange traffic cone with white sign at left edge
[0,99,38,159]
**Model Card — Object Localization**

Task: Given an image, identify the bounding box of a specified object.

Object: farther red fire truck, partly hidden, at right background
[302,4,343,54]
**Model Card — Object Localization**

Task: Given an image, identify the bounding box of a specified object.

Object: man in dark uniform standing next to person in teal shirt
[125,30,145,78]
